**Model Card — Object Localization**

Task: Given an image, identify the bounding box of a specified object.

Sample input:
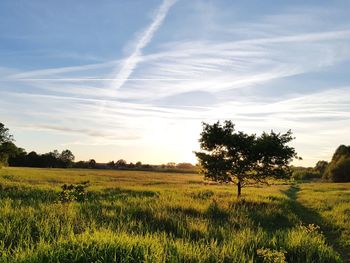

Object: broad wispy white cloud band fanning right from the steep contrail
[110,28,350,99]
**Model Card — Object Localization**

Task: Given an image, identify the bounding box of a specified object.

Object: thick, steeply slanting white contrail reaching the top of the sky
[112,0,177,90]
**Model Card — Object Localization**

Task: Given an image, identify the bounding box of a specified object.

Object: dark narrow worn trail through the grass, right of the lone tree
[281,185,350,262]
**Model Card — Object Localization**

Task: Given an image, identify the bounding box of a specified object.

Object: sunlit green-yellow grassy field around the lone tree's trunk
[0,168,350,262]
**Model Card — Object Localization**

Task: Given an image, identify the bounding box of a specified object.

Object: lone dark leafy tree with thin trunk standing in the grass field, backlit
[195,121,298,197]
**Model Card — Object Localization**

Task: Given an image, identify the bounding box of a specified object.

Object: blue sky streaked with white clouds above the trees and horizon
[0,0,350,166]
